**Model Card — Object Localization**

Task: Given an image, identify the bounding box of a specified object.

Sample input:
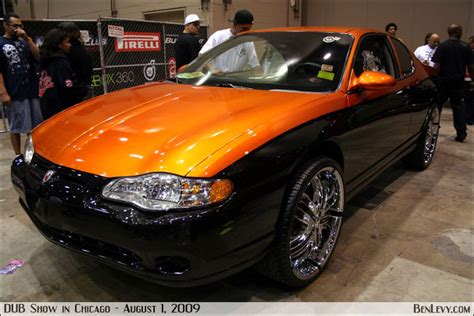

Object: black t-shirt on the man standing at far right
[431,38,474,81]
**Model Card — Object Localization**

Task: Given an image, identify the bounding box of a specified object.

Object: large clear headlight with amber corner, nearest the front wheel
[102,173,233,211]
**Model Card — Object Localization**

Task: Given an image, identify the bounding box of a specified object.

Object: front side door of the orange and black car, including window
[346,34,410,181]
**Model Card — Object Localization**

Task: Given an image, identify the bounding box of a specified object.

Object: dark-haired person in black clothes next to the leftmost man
[39,29,87,119]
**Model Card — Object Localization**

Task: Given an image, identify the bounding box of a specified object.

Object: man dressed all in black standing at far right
[432,24,474,142]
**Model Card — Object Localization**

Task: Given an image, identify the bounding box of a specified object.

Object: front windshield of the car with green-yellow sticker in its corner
[176,32,353,92]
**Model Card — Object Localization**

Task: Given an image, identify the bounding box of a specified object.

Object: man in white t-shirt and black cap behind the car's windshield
[199,10,259,73]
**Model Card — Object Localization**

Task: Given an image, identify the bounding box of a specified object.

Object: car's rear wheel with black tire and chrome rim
[403,105,441,170]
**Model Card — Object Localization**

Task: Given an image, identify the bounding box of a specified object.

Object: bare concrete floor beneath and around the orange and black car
[0,109,474,302]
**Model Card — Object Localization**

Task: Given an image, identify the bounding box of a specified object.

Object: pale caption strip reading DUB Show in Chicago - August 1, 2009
[0,302,472,316]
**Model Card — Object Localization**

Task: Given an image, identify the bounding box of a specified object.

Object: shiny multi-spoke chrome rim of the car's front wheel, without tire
[290,167,344,280]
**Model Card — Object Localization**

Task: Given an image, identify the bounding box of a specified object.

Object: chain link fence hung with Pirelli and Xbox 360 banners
[0,18,207,132]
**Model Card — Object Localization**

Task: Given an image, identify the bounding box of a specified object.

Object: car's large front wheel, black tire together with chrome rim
[257,156,345,288]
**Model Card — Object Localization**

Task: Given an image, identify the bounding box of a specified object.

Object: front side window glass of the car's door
[354,36,397,77]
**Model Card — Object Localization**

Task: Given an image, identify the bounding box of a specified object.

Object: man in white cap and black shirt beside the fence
[174,14,202,69]
